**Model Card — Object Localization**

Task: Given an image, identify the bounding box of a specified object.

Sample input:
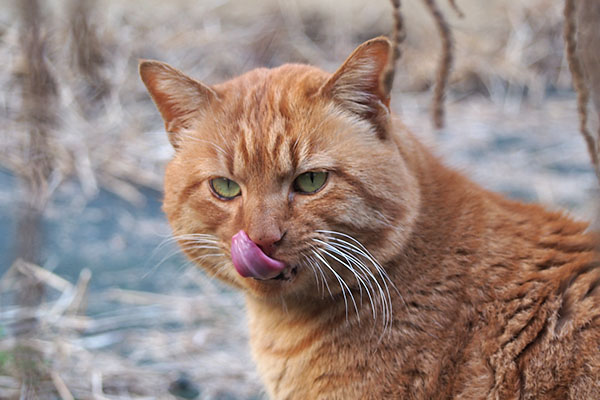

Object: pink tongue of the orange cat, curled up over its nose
[231,230,285,279]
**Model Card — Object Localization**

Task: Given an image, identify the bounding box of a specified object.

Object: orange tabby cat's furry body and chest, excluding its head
[248,129,600,399]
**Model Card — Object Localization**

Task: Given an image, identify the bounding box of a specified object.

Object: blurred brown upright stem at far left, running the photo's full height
[14,0,57,398]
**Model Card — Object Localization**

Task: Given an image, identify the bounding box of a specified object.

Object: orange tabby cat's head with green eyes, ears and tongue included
[140,38,418,297]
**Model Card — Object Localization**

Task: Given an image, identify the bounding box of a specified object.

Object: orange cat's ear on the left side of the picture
[139,60,218,149]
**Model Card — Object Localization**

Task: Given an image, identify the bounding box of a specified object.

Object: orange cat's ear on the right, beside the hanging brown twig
[320,37,392,136]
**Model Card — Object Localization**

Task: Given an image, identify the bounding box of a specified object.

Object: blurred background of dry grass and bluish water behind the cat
[0,0,598,399]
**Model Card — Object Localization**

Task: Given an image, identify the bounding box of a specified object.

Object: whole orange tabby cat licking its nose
[140,33,600,399]
